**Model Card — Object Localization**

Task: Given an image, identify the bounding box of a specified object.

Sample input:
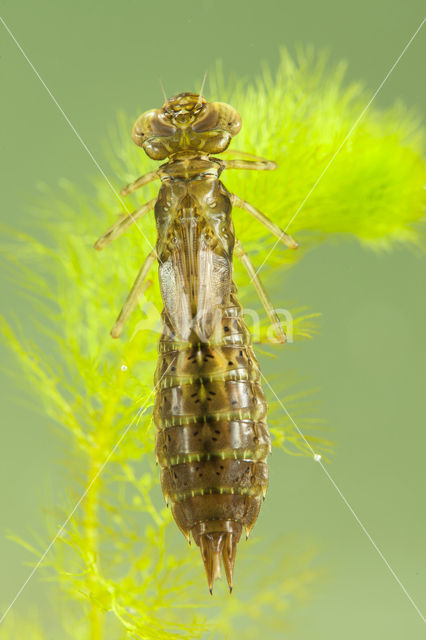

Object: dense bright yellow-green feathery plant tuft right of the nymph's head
[216,52,425,266]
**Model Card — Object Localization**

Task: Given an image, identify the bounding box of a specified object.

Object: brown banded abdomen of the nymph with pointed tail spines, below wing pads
[154,292,270,589]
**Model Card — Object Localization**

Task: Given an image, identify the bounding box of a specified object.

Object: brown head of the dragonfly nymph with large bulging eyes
[132,93,241,160]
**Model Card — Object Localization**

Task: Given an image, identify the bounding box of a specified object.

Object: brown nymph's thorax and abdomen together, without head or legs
[154,159,270,584]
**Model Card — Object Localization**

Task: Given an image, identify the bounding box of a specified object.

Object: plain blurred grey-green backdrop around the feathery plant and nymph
[0,0,426,640]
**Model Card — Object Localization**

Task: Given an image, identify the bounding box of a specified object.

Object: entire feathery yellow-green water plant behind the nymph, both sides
[0,53,424,640]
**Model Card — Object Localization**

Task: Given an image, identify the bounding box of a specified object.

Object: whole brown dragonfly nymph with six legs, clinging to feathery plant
[95,93,297,592]
